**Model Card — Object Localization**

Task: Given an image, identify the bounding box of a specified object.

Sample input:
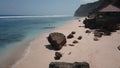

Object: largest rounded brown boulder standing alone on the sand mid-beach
[47,32,67,50]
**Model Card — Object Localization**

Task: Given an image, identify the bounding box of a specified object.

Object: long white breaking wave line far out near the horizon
[0,15,72,18]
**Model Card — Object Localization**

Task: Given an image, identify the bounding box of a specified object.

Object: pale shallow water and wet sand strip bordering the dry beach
[0,17,74,68]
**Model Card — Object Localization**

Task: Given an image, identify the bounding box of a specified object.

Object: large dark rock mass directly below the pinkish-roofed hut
[83,19,120,37]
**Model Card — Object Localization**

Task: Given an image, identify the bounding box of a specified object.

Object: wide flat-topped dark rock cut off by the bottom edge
[49,62,90,68]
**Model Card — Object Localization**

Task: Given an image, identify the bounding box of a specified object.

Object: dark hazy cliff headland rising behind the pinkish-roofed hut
[74,0,120,16]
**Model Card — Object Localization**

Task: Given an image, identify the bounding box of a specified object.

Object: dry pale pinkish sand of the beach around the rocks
[14,18,120,68]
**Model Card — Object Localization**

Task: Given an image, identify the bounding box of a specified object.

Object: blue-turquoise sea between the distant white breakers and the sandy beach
[0,16,75,67]
